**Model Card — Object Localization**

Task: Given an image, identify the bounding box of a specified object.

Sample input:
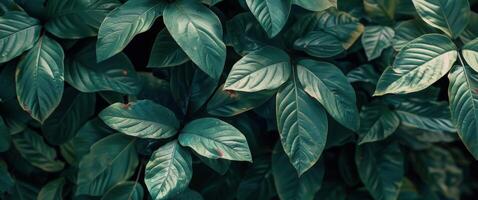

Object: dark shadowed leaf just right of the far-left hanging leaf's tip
[42,88,96,145]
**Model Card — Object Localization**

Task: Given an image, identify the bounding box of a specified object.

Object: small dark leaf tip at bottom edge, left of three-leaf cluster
[101,181,144,200]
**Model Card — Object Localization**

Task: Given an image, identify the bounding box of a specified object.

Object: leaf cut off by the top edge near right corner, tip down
[412,0,470,39]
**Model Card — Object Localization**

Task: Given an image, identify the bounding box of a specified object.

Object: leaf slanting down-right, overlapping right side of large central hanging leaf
[296,59,359,131]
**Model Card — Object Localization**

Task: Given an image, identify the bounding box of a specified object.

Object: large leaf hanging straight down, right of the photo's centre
[276,73,327,176]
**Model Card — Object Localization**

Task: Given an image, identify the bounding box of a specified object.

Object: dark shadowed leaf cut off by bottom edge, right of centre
[355,143,405,200]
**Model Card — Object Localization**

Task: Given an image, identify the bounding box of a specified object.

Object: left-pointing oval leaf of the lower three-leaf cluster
[99,100,179,139]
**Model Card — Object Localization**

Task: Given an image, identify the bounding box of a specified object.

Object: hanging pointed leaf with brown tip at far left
[15,36,65,123]
